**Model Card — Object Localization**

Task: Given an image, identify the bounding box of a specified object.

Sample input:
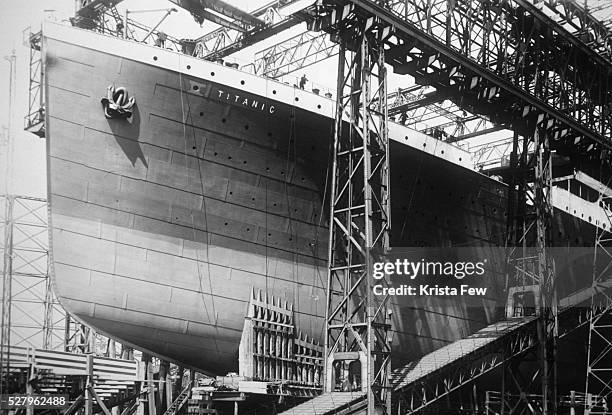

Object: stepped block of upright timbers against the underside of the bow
[239,290,323,395]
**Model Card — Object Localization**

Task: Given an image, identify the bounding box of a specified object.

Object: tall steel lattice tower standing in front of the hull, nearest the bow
[325,13,391,415]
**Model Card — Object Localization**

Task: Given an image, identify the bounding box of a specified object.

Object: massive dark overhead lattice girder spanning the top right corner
[318,0,612,165]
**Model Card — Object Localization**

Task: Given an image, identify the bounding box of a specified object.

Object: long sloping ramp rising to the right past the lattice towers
[282,278,612,415]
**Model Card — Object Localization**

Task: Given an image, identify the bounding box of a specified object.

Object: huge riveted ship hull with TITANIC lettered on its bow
[43,22,593,374]
